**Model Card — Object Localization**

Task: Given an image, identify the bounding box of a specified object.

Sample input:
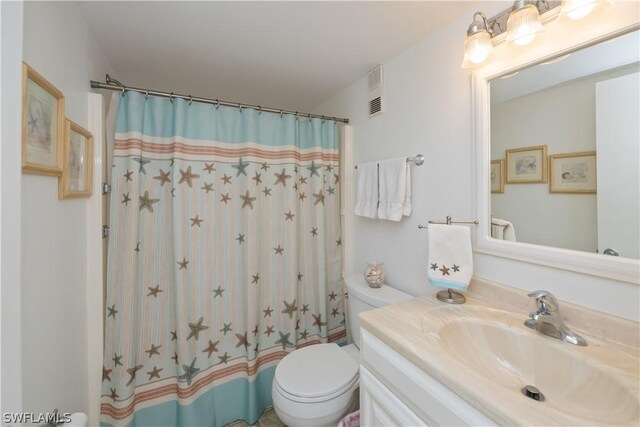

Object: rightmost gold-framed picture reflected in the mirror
[549,151,596,194]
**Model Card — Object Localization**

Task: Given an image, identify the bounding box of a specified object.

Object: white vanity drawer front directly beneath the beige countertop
[360,329,497,426]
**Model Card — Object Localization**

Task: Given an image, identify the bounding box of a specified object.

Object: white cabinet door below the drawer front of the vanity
[360,366,427,427]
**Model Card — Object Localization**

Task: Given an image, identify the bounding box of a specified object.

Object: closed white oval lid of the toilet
[275,344,359,397]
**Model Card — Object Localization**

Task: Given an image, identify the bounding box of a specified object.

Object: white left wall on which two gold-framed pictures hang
[20,2,112,413]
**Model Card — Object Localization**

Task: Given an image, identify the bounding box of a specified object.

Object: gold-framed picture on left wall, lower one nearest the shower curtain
[58,120,93,199]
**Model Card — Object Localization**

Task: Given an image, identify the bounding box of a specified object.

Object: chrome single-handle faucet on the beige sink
[524,291,587,346]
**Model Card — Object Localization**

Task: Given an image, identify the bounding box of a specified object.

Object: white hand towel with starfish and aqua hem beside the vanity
[429,224,473,291]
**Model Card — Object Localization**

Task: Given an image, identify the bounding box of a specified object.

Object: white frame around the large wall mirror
[471,2,640,285]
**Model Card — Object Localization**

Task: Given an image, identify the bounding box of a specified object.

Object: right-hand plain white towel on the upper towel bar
[378,157,411,221]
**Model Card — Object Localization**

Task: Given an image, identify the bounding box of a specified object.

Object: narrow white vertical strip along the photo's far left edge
[0,1,23,413]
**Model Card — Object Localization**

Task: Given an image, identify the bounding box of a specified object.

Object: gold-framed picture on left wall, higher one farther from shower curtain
[22,63,64,176]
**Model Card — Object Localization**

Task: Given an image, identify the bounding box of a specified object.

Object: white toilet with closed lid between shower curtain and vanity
[271,275,413,427]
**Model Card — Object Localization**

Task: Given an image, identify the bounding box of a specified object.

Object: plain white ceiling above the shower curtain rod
[79,1,474,112]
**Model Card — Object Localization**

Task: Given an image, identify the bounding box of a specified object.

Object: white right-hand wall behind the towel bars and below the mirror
[316,2,640,320]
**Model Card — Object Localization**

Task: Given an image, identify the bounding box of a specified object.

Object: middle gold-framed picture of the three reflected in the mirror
[506,145,547,184]
